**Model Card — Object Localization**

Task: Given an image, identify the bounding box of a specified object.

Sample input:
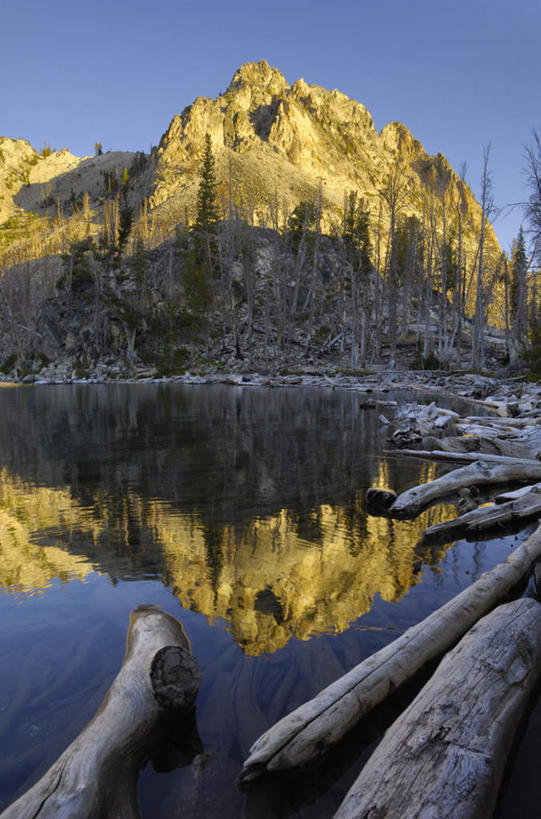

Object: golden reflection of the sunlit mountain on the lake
[0,469,450,655]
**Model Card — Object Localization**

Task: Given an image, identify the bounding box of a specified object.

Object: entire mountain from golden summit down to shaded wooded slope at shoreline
[0,60,508,379]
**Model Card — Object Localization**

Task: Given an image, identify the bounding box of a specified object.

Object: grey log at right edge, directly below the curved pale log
[423,486,541,543]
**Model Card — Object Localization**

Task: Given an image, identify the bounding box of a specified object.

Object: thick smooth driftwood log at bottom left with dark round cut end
[2,607,201,819]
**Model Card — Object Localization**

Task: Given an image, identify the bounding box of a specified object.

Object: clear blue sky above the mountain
[0,0,541,249]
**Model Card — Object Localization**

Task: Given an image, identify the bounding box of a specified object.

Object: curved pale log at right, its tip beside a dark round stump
[386,460,541,518]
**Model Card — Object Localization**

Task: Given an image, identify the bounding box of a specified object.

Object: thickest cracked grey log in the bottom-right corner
[334,599,541,819]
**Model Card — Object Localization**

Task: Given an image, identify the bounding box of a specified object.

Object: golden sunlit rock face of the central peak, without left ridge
[151,60,497,258]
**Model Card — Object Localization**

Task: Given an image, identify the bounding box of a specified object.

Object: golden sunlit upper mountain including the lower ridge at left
[0,60,498,260]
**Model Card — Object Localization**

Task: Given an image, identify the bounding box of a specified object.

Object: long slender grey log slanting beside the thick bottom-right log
[240,526,541,783]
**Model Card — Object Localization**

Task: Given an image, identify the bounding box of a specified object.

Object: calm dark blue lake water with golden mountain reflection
[0,384,532,819]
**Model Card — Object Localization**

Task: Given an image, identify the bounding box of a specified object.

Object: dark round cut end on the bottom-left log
[150,646,201,711]
